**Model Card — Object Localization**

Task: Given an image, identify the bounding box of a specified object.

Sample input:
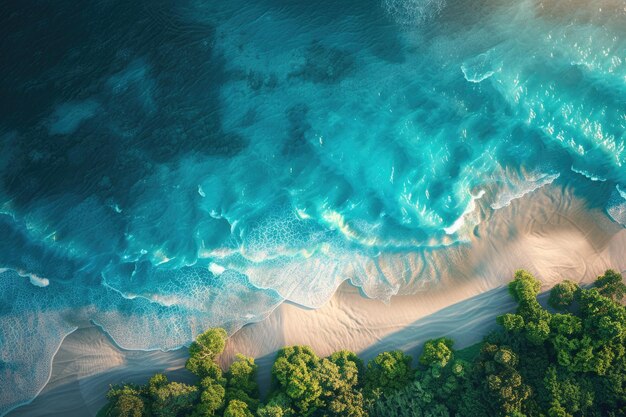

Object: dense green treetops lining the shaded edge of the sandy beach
[100,270,626,417]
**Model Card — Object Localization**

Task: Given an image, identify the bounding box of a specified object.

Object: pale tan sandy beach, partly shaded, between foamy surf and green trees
[10,186,626,417]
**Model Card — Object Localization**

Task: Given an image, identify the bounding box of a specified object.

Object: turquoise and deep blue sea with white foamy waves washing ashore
[0,0,626,414]
